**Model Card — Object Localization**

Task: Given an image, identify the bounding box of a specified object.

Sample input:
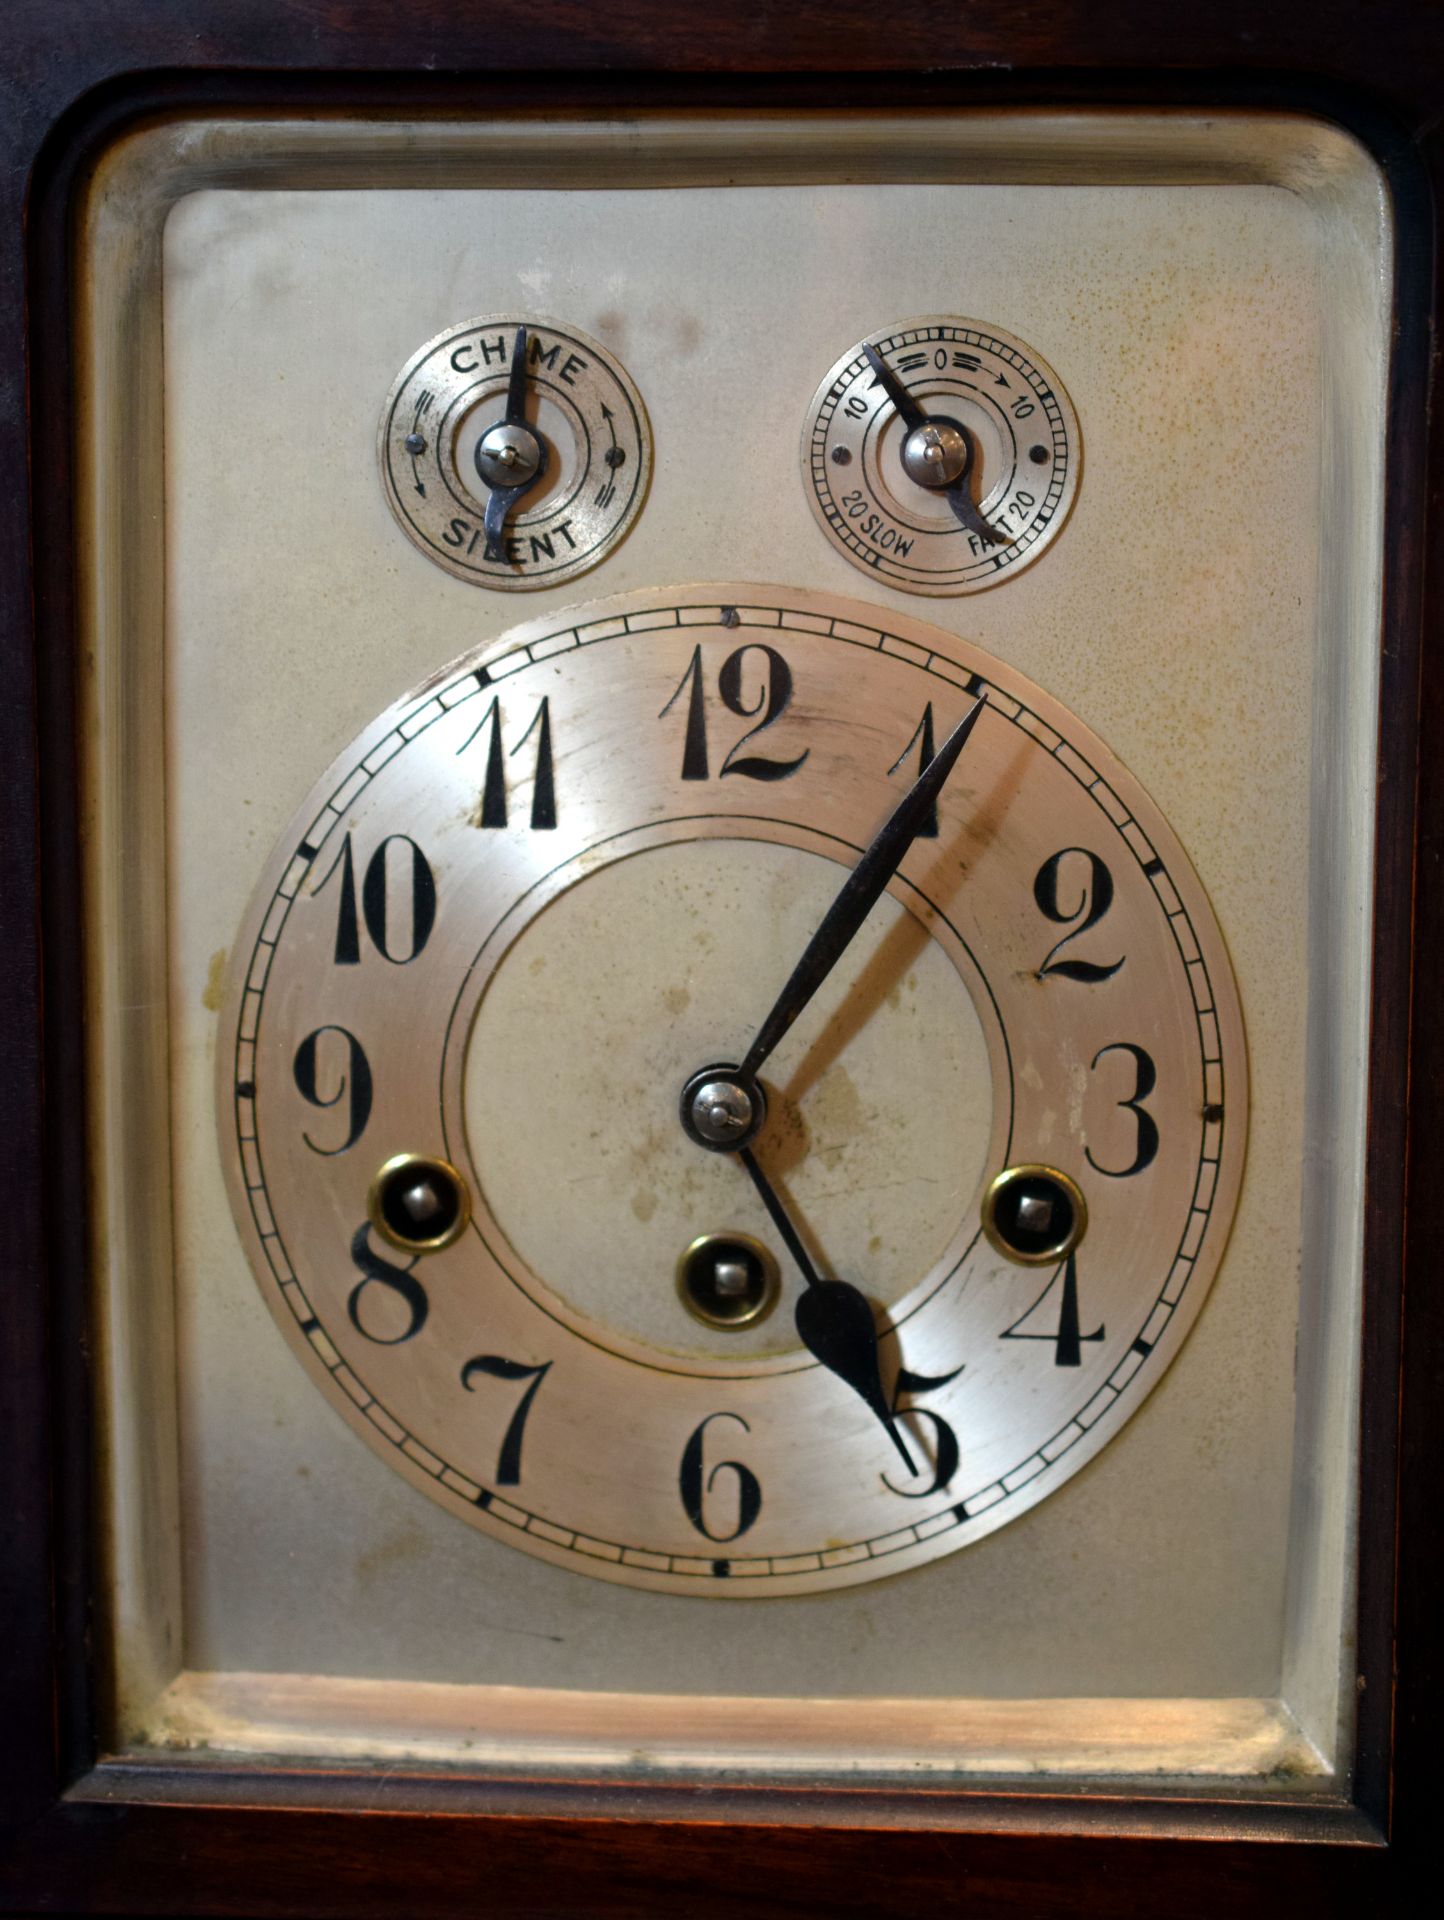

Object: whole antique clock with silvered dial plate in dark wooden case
[5,8,1436,1912]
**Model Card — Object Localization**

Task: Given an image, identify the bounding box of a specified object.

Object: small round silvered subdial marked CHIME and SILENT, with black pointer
[380,313,651,593]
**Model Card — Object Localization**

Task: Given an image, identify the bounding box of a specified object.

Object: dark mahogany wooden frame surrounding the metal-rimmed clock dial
[0,0,1444,1916]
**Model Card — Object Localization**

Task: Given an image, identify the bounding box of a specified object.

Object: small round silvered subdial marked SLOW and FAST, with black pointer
[803,315,1081,595]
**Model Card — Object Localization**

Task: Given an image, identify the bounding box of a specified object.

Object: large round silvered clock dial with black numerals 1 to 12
[219,584,1246,1597]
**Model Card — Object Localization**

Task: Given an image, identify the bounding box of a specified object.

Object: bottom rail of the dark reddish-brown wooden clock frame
[0,1770,1406,1920]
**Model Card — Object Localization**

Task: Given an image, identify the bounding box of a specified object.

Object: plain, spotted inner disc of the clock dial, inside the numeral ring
[463,822,993,1361]
